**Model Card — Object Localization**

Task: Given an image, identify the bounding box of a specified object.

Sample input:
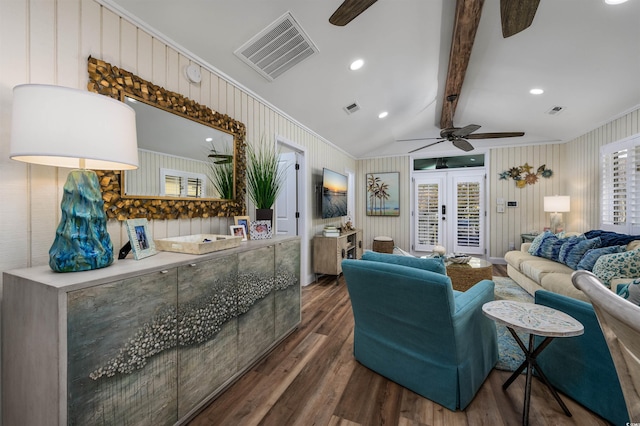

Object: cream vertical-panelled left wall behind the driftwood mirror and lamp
[0,0,356,286]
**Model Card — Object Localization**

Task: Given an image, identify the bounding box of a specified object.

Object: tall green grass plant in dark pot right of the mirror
[247,139,285,223]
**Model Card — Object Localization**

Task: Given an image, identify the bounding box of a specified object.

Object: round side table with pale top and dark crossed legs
[482,300,584,425]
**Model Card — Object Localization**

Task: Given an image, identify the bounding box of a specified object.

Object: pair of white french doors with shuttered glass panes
[413,170,486,255]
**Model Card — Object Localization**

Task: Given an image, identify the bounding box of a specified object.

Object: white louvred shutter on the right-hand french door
[454,176,484,254]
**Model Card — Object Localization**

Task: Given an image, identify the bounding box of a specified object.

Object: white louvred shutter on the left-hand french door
[414,178,443,251]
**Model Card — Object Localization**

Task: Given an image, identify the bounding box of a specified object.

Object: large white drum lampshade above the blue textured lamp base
[9,84,138,170]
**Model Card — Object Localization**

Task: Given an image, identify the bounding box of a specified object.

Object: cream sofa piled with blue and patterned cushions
[504,230,640,302]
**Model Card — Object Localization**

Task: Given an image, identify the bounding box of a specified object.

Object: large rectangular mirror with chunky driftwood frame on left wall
[87,57,246,220]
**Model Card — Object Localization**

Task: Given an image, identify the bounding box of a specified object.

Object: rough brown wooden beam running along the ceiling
[440,0,484,129]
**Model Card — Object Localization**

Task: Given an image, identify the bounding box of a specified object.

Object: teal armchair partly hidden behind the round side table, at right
[535,290,629,426]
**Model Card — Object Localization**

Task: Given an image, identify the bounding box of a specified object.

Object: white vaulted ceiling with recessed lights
[105,0,640,158]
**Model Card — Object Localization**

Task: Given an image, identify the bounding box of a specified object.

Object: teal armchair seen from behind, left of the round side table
[342,253,498,411]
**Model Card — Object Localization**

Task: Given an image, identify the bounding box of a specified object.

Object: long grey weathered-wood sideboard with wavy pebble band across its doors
[2,237,300,425]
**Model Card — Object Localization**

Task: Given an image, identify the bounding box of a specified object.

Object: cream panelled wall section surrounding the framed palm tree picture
[355,156,411,251]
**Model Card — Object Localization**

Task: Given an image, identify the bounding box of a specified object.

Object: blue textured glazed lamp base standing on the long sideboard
[49,170,113,272]
